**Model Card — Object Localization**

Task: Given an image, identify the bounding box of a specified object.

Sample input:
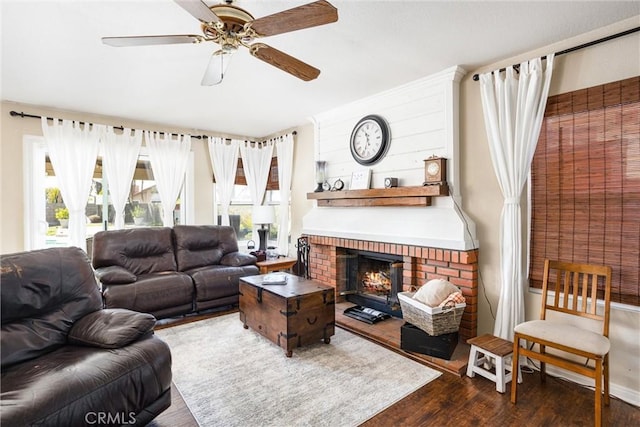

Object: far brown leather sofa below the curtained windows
[92,225,258,319]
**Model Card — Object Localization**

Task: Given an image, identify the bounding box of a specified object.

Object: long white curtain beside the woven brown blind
[480,54,554,341]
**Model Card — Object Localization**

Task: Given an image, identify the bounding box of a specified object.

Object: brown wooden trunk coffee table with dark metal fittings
[240,273,335,357]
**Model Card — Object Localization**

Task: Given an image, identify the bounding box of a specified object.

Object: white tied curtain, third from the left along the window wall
[144,131,191,227]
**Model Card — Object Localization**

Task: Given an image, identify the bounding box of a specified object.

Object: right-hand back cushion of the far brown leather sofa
[173,225,244,271]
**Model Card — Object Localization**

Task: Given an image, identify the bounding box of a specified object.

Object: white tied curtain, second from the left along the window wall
[102,126,142,230]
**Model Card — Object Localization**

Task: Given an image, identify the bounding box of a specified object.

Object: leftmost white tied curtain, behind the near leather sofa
[42,117,104,251]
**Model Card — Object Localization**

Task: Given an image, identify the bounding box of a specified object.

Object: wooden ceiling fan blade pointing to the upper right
[250,0,338,37]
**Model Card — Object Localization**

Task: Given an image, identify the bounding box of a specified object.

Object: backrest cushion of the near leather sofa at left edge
[0,248,102,369]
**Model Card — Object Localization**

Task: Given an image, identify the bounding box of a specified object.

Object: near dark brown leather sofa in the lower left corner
[0,248,171,426]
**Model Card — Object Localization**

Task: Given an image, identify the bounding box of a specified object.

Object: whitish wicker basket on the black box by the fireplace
[398,292,467,336]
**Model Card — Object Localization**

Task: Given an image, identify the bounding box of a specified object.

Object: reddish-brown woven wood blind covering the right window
[530,77,640,306]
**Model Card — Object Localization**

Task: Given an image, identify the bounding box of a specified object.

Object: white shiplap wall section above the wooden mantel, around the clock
[314,67,463,188]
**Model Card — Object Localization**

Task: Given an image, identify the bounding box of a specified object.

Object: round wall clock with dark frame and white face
[350,115,391,165]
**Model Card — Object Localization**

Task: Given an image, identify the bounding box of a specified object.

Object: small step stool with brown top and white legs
[467,334,522,393]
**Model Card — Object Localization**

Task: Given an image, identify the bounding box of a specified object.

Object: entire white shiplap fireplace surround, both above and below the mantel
[302,67,477,250]
